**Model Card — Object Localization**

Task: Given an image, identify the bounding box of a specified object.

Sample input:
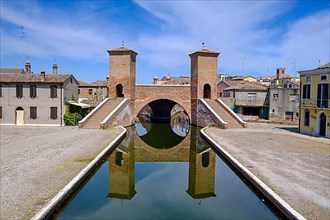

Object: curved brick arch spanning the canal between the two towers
[134,94,191,119]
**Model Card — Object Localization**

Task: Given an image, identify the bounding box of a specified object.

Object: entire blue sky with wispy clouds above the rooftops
[0,0,330,83]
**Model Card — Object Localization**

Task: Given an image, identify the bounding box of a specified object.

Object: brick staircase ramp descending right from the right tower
[204,99,246,128]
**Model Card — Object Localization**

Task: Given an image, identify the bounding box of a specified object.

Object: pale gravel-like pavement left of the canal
[0,126,122,219]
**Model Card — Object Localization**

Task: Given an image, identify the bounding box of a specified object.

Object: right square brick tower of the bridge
[189,48,220,126]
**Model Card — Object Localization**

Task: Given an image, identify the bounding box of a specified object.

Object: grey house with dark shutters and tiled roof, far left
[0,64,78,126]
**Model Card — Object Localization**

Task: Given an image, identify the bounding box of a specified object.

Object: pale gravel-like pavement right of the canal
[206,123,330,220]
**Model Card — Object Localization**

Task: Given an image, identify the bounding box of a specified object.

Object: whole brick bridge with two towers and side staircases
[79,47,246,129]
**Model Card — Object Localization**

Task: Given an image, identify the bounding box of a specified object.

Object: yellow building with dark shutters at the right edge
[299,63,330,138]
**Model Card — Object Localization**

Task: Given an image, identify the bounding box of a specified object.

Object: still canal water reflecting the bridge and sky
[55,120,280,219]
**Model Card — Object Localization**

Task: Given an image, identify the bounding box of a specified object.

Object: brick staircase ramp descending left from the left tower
[79,98,124,128]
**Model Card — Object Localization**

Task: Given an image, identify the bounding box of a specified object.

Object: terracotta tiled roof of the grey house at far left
[0,73,72,83]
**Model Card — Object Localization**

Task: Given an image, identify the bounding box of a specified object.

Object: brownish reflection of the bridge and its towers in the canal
[108,123,216,199]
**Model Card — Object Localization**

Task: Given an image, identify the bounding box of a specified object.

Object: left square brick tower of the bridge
[108,46,137,100]
